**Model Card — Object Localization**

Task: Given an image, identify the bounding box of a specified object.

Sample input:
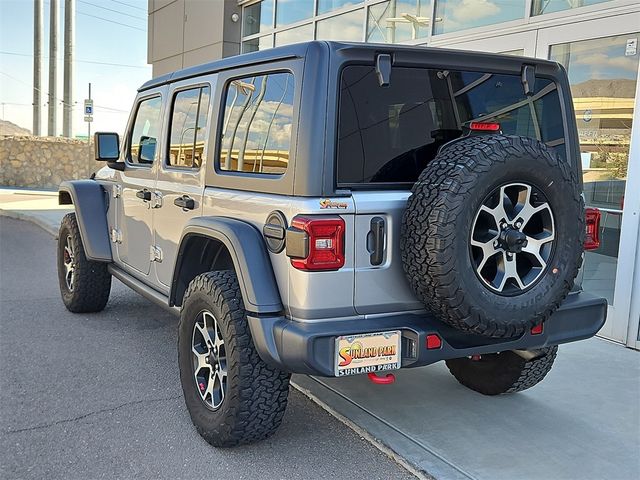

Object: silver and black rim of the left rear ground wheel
[191,310,227,410]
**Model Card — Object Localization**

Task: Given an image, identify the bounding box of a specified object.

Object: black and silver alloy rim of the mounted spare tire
[470,183,555,295]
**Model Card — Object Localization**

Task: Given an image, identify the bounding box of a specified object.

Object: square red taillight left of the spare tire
[287,215,345,271]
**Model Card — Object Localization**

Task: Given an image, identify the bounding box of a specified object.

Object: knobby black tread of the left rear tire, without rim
[180,271,290,447]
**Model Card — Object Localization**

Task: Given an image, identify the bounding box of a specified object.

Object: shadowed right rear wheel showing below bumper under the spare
[446,345,558,395]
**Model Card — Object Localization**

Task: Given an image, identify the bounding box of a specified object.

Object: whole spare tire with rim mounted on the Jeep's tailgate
[401,135,585,338]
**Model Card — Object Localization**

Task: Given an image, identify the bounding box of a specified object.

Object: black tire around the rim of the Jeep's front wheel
[58,212,111,313]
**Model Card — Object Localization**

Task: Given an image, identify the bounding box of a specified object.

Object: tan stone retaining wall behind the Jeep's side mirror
[0,136,101,189]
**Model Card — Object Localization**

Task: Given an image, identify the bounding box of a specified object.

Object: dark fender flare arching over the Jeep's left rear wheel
[169,216,283,314]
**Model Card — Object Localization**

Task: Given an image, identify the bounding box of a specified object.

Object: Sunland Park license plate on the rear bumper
[335,330,402,377]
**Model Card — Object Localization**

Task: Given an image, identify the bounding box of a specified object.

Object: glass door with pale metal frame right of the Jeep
[536,14,640,345]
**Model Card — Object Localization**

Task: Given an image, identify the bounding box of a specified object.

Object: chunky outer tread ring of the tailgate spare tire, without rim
[400,135,585,338]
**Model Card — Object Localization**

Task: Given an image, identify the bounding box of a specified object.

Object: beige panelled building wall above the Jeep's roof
[147,0,242,77]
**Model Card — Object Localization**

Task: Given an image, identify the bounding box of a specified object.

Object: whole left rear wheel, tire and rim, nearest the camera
[178,271,290,447]
